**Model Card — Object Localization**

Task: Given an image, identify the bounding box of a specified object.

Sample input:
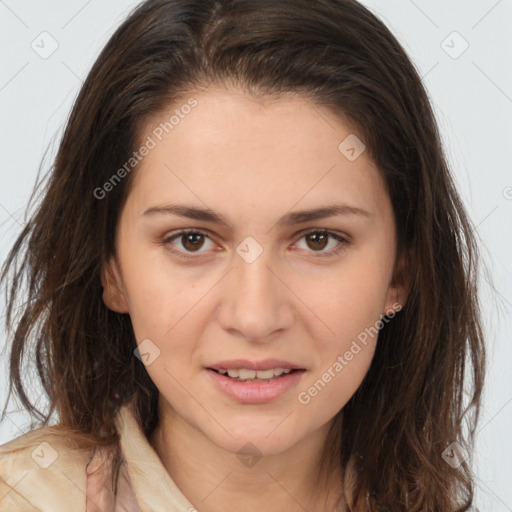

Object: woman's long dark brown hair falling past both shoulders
[2,0,485,512]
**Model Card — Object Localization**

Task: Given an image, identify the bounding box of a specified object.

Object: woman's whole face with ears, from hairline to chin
[102,88,404,454]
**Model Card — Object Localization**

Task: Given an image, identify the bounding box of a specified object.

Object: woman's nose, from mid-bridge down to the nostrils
[218,246,296,343]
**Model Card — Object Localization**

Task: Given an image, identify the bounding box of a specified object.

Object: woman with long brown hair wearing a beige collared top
[0,0,485,512]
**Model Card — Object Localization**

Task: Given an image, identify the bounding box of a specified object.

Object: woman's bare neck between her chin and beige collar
[149,400,345,512]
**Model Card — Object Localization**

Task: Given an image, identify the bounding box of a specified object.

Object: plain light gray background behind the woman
[0,0,512,512]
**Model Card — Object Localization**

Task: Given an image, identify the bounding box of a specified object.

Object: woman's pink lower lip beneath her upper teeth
[207,369,305,404]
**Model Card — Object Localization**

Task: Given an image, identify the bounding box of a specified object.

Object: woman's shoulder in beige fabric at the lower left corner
[0,427,91,512]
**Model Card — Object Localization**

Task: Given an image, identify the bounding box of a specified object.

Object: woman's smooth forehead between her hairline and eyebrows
[128,88,386,222]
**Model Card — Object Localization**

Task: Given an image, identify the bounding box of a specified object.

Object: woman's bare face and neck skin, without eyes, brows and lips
[102,86,406,512]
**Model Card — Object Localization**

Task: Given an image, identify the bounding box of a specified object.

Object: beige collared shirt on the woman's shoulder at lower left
[0,405,196,512]
